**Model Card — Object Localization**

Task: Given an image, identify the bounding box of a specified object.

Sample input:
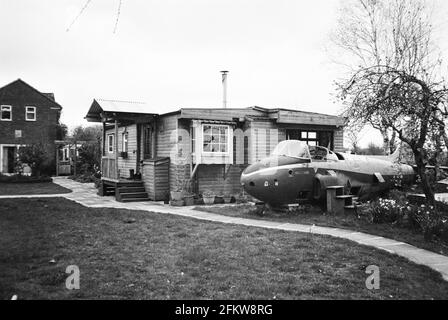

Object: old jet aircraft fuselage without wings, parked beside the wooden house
[241,140,415,207]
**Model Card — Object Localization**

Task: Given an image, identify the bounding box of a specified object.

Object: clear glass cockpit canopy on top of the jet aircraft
[272,140,338,161]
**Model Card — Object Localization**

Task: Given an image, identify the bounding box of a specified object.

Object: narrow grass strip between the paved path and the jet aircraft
[195,204,448,255]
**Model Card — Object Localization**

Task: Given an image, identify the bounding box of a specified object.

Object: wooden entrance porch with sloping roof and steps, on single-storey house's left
[86,99,156,202]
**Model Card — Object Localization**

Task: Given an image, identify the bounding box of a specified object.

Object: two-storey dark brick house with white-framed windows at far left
[0,79,62,174]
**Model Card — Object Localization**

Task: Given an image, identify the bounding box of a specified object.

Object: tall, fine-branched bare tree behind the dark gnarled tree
[332,0,438,153]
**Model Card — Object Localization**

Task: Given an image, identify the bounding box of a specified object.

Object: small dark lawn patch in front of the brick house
[0,182,71,196]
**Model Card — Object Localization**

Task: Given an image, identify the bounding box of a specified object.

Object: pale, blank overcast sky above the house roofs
[0,0,448,145]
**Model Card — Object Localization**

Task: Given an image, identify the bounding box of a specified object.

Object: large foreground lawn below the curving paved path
[0,198,448,299]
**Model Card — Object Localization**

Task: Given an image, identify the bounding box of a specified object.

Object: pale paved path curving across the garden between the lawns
[5,177,448,281]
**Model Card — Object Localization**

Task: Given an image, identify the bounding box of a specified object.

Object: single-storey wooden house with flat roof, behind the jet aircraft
[85,99,345,200]
